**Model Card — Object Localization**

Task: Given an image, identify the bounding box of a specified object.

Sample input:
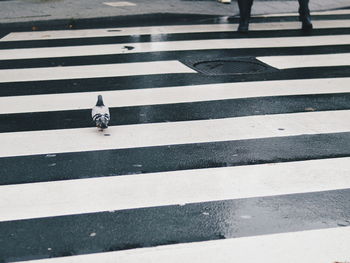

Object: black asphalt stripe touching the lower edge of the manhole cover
[0,66,350,97]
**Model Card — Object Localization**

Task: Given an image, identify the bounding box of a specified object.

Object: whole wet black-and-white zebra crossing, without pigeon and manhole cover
[0,10,350,263]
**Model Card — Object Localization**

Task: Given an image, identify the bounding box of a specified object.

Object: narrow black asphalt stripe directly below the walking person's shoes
[0,25,350,49]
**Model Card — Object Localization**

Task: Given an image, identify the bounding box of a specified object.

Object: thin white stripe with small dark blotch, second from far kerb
[0,34,350,60]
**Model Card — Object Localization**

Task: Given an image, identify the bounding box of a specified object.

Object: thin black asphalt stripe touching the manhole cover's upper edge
[0,45,350,69]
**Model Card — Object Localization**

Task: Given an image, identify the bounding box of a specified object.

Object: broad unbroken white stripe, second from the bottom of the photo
[0,158,350,224]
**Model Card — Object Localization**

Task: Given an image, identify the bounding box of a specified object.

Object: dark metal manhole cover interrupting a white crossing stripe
[183,57,278,75]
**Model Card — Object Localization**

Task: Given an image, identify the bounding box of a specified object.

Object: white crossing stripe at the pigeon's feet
[0,110,350,157]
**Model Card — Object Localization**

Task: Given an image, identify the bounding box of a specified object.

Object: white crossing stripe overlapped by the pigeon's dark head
[0,78,350,114]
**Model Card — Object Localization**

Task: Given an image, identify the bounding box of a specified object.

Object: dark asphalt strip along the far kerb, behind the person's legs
[0,10,350,38]
